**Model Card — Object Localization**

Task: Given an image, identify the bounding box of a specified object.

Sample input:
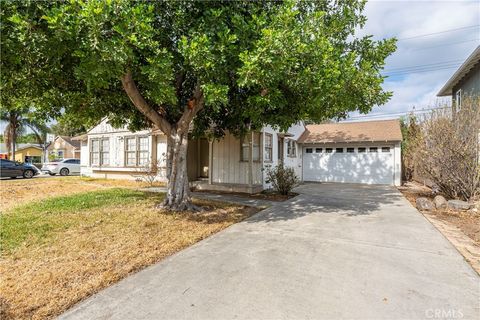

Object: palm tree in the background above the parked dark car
[0,109,49,160]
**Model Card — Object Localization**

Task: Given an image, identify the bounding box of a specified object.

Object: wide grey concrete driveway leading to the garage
[61,184,480,319]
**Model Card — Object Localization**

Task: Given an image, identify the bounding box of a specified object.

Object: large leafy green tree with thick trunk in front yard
[2,0,395,210]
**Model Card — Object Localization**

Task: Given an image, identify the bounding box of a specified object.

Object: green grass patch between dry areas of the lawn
[0,189,151,255]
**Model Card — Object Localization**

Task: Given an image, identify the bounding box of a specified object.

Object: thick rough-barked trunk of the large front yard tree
[162,129,199,211]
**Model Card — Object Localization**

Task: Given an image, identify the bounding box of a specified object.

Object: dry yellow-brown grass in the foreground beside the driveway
[0,189,257,319]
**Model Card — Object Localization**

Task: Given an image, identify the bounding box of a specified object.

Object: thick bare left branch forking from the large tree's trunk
[121,71,171,134]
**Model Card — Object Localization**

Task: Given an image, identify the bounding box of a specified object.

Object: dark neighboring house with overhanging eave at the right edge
[437,45,480,109]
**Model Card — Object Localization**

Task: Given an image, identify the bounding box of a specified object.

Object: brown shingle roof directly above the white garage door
[298,120,402,143]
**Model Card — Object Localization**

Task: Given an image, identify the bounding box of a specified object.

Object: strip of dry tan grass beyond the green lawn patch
[0,176,163,212]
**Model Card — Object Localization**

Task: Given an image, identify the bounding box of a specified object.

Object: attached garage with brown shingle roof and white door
[299,120,401,185]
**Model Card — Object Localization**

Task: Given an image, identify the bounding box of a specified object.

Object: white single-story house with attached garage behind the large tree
[76,119,402,193]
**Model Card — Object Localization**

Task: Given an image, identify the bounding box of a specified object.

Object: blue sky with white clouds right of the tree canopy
[350,0,480,120]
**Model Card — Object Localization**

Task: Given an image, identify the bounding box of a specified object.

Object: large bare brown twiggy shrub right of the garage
[413,98,480,200]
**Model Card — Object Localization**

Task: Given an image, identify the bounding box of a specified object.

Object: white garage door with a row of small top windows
[303,145,394,185]
